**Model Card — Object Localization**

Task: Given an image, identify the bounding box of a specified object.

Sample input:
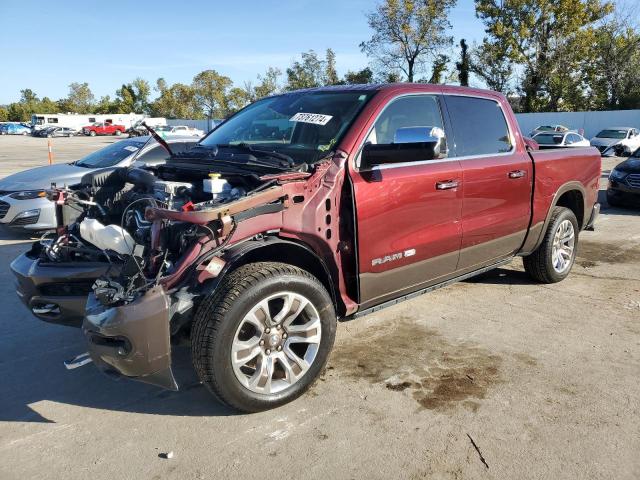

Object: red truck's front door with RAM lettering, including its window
[351,94,462,308]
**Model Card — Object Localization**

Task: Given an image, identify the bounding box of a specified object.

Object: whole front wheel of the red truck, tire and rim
[191,262,336,412]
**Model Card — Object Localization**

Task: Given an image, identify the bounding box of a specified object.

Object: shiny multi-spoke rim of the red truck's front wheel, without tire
[231,292,322,395]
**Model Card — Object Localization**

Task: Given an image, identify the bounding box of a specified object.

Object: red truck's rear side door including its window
[445,95,533,273]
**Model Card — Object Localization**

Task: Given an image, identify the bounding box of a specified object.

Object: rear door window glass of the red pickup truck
[446,95,512,157]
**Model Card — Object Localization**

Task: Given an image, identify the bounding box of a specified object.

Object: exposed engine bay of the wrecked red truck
[39,145,296,305]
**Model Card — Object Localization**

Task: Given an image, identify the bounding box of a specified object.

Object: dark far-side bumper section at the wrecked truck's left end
[10,252,109,327]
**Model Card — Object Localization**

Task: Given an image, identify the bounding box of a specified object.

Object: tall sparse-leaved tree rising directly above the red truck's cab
[360,0,456,82]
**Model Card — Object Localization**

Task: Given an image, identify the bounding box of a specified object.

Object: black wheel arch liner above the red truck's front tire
[201,235,342,311]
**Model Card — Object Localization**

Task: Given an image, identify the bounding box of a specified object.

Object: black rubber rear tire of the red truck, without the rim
[522,207,580,283]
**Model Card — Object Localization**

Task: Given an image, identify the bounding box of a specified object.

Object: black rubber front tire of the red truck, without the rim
[191,262,336,412]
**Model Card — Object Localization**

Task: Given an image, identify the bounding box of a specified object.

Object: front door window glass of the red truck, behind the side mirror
[367,95,444,145]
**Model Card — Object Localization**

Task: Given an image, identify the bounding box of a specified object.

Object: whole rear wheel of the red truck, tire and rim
[522,207,579,283]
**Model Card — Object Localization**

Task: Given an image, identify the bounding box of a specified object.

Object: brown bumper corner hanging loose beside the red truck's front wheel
[82,286,178,390]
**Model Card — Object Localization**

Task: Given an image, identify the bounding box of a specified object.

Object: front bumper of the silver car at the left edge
[0,195,57,231]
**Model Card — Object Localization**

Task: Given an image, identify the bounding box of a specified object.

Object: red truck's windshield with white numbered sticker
[200,91,375,163]
